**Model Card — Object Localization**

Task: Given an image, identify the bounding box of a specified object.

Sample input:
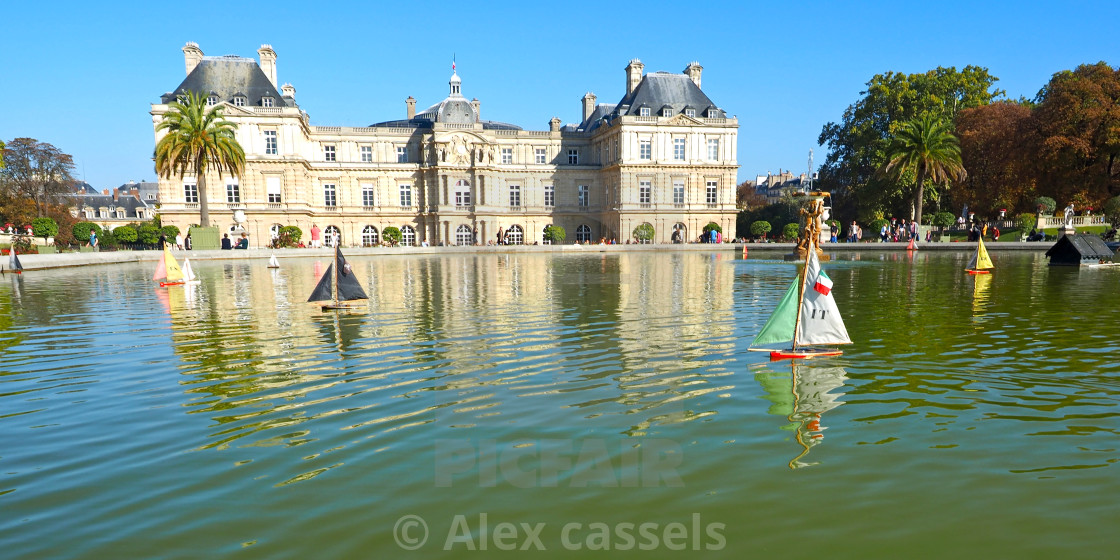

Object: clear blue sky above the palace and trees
[0,0,1120,188]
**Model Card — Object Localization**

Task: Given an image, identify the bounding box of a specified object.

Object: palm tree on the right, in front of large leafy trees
[883,114,965,224]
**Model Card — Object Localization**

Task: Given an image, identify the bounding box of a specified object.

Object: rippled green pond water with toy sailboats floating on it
[0,252,1120,560]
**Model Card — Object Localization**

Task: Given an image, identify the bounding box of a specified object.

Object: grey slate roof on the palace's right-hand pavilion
[578,72,727,131]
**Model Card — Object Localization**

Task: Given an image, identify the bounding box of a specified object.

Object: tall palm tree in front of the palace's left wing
[156,92,245,227]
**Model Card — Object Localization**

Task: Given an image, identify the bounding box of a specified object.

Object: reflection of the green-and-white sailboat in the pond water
[755,360,848,468]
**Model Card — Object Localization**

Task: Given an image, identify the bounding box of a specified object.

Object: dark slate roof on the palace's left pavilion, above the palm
[160,55,298,106]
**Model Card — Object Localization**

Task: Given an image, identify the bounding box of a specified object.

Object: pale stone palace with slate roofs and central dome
[151,43,738,246]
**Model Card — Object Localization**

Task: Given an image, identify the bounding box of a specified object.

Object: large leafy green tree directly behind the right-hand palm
[818,66,1005,221]
